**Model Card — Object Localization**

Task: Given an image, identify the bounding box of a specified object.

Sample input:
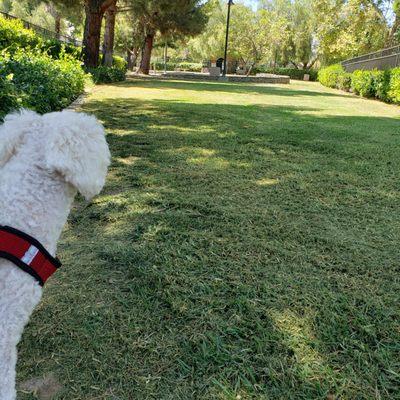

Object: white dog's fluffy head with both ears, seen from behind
[0,111,110,200]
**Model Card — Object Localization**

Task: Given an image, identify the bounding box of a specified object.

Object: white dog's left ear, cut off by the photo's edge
[0,110,41,168]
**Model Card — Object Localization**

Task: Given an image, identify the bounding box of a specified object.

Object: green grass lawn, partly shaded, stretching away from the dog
[19,80,400,400]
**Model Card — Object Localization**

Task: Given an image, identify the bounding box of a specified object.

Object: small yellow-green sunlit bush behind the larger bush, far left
[0,17,43,53]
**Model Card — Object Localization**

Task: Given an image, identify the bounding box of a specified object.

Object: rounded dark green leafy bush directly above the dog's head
[4,51,87,113]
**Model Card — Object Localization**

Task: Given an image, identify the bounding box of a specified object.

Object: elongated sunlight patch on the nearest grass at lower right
[270,309,326,378]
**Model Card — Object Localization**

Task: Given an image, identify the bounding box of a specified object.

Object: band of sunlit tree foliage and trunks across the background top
[0,0,400,73]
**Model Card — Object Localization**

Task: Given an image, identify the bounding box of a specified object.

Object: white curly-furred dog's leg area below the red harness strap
[0,267,42,400]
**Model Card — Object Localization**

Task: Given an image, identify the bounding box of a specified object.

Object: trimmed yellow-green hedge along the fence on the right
[318,64,400,104]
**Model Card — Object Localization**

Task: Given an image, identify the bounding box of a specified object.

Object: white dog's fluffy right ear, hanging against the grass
[43,111,110,200]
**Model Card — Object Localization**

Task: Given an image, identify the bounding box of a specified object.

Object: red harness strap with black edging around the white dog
[0,225,61,286]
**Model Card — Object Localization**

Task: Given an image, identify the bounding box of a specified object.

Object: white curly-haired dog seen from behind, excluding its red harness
[0,111,110,400]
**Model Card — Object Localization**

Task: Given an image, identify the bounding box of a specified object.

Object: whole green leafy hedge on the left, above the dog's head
[0,17,89,118]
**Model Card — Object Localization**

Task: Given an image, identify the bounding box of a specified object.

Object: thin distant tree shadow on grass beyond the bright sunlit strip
[115,78,351,98]
